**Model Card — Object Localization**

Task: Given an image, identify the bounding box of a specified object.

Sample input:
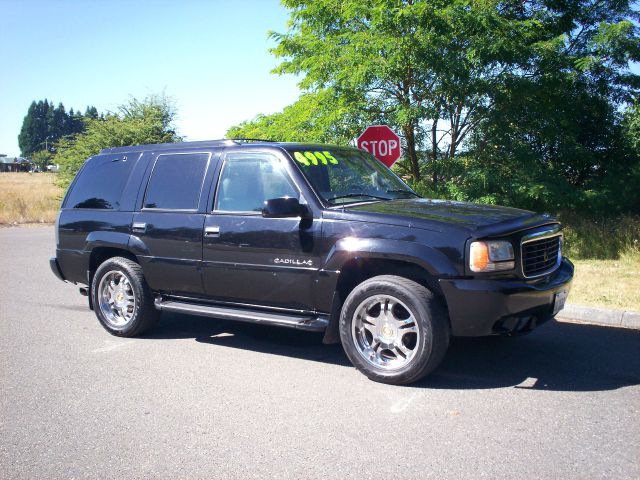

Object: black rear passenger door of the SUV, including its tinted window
[130,151,217,295]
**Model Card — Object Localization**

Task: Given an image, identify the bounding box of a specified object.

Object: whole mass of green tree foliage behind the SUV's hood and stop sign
[248,0,640,218]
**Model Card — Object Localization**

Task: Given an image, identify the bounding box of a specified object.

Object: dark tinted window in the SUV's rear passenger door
[144,153,209,210]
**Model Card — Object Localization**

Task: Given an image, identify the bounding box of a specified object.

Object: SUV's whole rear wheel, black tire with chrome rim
[91,257,160,337]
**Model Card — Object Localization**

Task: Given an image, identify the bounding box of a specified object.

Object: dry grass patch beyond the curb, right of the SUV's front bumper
[568,252,640,311]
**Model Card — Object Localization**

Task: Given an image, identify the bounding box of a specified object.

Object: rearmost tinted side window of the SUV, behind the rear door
[65,154,139,210]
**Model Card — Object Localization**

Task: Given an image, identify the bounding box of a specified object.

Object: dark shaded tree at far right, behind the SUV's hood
[460,1,640,211]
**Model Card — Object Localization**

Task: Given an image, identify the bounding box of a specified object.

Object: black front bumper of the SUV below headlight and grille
[440,258,573,337]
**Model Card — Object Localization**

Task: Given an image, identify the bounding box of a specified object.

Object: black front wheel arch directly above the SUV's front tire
[336,258,442,302]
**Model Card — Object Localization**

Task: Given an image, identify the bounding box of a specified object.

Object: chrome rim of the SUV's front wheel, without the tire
[351,295,420,370]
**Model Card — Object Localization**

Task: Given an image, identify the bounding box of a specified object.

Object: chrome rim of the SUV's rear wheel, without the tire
[98,270,136,329]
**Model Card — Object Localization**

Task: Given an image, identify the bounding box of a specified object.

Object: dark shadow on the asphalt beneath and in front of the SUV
[146,312,640,391]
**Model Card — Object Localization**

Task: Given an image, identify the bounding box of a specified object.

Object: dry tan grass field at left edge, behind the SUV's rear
[0,172,63,225]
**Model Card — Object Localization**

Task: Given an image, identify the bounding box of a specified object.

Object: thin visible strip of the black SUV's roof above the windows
[100,138,353,154]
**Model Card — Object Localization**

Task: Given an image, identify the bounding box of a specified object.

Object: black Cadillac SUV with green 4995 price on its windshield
[51,140,573,384]
